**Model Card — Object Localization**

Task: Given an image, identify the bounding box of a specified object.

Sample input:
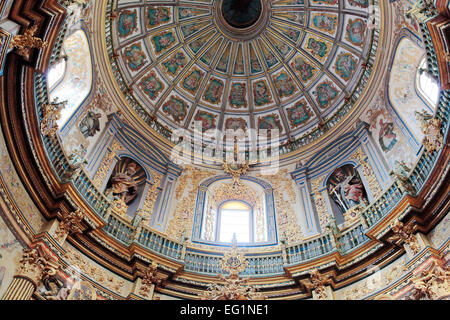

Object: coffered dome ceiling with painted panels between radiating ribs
[110,0,371,146]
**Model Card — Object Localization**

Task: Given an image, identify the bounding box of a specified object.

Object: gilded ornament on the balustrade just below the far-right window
[415,110,444,153]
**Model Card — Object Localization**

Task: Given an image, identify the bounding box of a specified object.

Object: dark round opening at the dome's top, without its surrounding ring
[222,0,262,29]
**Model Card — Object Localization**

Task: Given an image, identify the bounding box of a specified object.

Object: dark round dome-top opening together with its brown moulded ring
[214,0,270,41]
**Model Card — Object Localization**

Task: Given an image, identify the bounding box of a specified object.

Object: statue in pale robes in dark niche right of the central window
[327,165,368,213]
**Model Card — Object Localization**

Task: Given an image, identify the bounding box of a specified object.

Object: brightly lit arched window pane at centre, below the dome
[217,201,253,242]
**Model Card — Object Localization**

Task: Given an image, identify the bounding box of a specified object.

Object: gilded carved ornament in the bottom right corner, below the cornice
[409,260,450,300]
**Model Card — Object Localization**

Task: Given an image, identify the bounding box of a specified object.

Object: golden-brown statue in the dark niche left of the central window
[105,158,146,206]
